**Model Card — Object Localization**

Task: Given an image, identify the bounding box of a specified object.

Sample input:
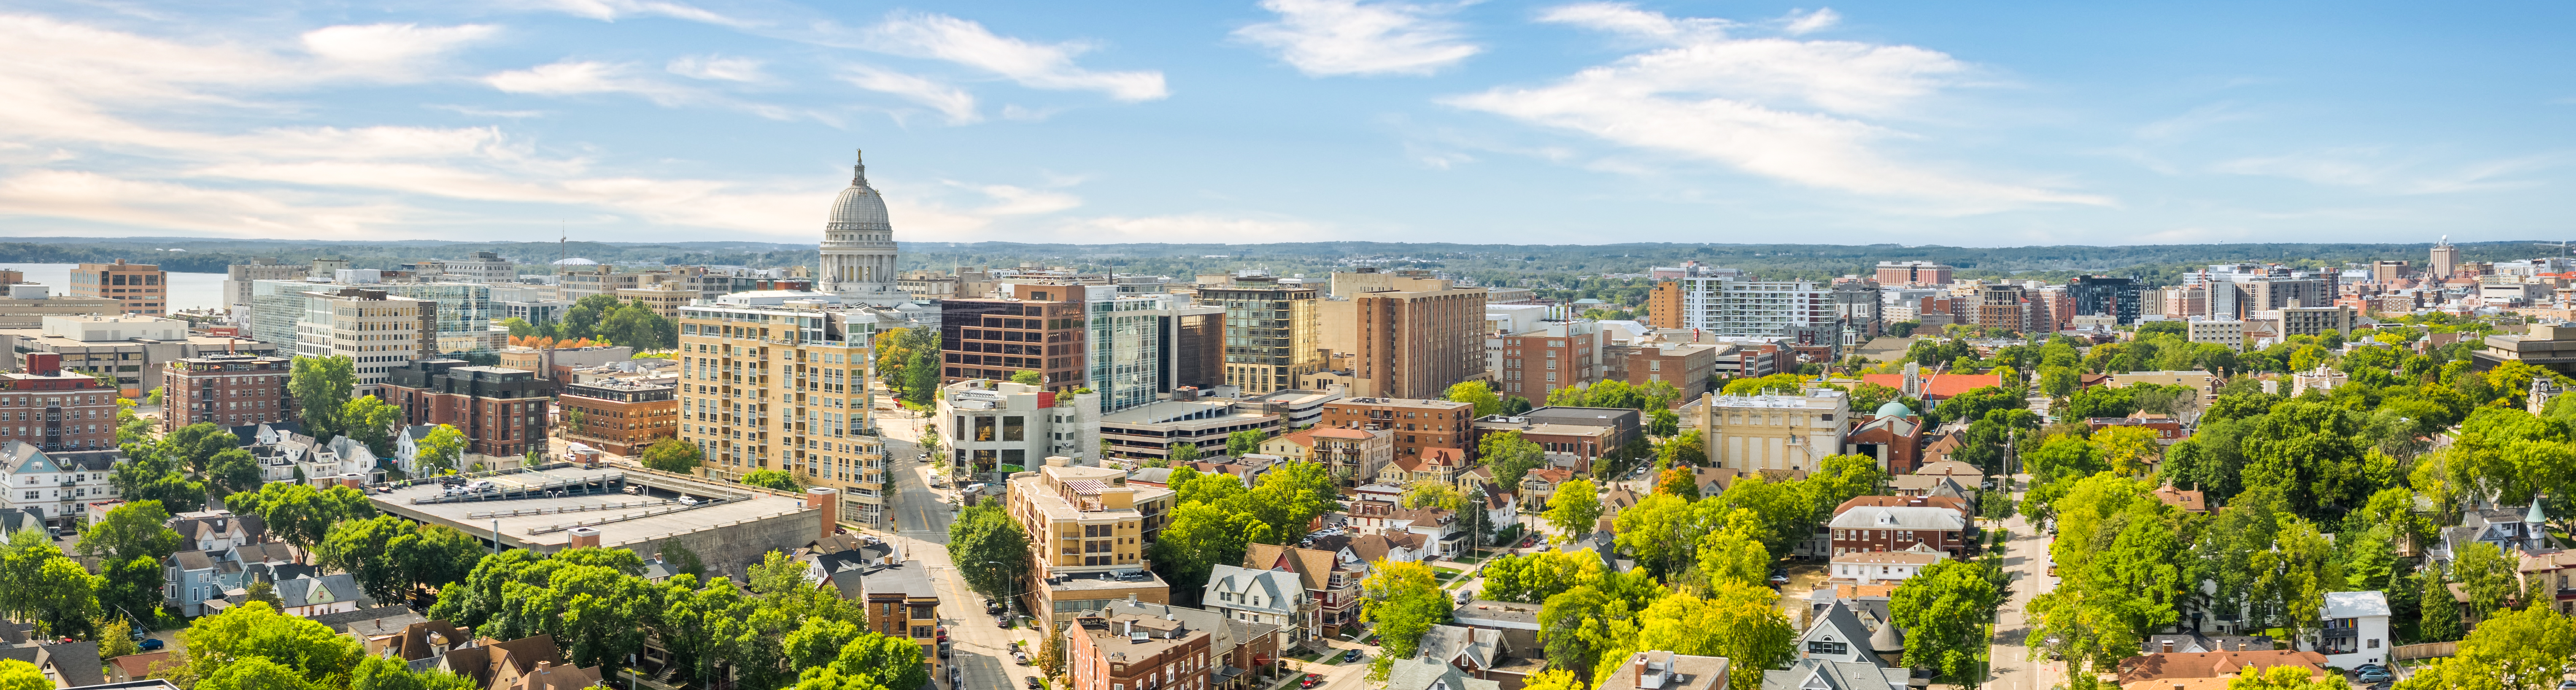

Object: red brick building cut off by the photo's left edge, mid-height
[0,353,116,451]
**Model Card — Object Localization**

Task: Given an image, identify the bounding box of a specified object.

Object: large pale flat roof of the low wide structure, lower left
[368,466,806,551]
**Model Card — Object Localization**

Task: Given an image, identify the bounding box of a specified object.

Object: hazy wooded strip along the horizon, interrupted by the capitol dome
[0,237,2563,291]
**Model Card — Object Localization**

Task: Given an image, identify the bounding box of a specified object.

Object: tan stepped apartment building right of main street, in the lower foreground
[1010,456,1177,623]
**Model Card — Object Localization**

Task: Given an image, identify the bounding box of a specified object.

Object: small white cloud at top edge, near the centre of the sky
[1234,0,1481,77]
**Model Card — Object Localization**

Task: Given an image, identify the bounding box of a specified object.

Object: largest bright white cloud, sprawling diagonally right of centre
[1445,3,2110,214]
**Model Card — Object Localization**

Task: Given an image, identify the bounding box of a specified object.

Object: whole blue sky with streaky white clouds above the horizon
[0,0,2576,247]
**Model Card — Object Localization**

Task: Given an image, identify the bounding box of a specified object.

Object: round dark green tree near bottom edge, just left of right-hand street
[1888,561,2004,680]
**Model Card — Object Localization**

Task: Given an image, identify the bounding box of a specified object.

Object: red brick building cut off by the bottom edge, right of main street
[1064,613,1213,690]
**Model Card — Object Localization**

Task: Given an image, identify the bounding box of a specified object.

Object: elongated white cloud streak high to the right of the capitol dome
[865,13,1172,103]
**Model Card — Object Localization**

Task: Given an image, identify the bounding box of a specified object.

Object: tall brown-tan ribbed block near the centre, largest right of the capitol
[1326,286,1484,397]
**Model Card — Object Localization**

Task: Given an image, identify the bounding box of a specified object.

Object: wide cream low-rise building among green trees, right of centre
[1682,389,1852,471]
